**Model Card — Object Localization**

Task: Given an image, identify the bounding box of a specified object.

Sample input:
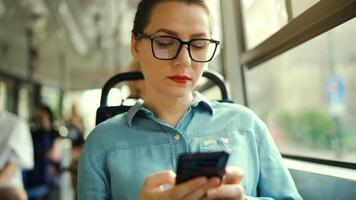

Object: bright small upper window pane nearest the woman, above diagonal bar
[241,0,288,49]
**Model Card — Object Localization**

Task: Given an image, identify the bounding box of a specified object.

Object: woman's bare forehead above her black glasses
[145,1,211,35]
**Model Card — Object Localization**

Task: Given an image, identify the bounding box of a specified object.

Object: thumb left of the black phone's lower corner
[143,170,176,189]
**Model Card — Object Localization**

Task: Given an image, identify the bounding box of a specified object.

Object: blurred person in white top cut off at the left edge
[0,112,33,200]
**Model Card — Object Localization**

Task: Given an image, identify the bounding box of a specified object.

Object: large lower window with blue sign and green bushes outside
[246,18,356,163]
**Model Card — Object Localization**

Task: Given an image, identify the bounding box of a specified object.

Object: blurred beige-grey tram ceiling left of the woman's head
[0,0,138,90]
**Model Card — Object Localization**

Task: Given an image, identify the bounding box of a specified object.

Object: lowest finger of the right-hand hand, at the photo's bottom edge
[207,184,244,199]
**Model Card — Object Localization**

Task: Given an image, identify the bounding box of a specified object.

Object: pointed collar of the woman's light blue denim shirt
[126,91,214,127]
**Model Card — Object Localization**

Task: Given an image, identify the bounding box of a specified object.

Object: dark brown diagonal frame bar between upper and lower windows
[238,0,356,69]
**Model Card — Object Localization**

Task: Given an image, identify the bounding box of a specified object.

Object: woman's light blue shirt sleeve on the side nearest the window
[257,122,302,200]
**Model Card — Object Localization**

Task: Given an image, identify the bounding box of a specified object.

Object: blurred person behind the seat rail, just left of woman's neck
[128,60,145,99]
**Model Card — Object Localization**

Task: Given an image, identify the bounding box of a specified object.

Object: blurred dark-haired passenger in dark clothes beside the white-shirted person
[24,105,61,200]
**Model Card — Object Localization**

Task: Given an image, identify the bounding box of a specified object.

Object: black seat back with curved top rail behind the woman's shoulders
[95,71,232,125]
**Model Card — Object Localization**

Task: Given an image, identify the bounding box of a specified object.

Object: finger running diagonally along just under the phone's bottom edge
[167,177,208,199]
